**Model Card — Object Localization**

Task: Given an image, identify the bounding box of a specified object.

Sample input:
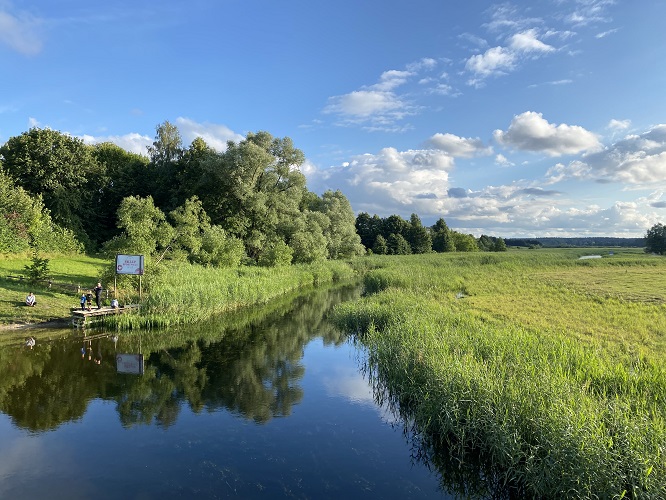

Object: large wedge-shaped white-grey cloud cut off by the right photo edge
[547,125,666,187]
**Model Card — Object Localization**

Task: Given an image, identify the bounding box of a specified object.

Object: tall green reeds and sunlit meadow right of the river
[336,249,666,498]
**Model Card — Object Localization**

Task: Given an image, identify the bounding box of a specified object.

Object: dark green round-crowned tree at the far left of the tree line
[0,128,106,245]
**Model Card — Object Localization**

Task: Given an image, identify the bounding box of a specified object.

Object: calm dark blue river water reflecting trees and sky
[0,288,445,499]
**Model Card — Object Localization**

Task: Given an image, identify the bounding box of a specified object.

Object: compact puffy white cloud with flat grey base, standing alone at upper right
[493,111,601,156]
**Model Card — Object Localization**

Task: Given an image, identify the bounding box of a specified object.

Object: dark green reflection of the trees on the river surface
[0,288,358,431]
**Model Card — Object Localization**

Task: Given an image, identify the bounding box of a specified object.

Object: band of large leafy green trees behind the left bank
[0,121,364,265]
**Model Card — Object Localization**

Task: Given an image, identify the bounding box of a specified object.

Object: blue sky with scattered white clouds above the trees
[0,0,666,238]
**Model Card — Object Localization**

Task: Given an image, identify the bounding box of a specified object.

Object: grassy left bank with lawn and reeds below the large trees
[0,256,356,329]
